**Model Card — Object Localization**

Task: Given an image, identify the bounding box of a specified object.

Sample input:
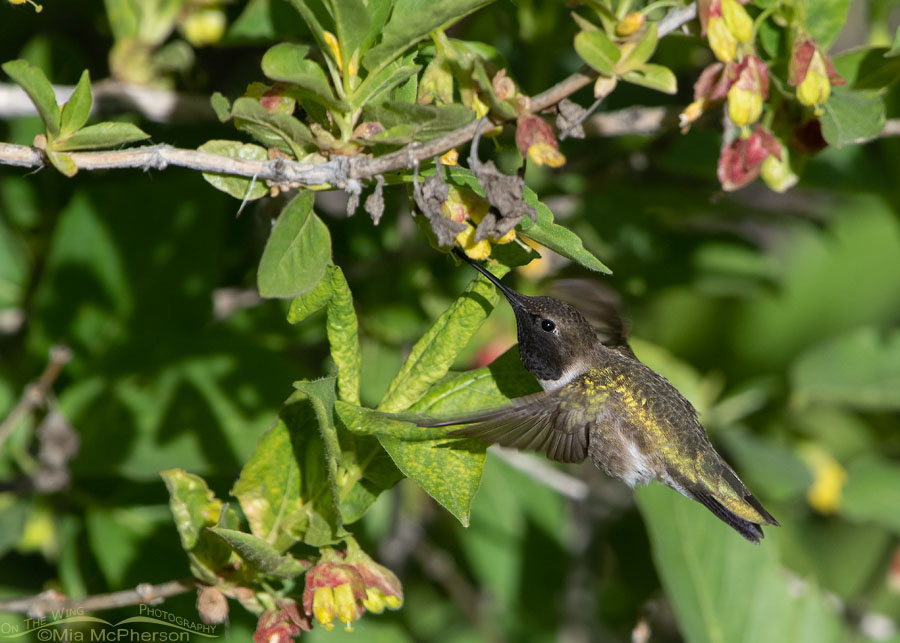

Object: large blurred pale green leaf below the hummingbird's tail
[636,483,847,643]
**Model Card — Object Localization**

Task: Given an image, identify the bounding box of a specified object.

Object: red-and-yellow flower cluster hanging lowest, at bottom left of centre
[303,541,403,632]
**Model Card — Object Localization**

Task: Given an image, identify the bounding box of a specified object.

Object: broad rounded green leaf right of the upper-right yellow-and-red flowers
[821,87,885,147]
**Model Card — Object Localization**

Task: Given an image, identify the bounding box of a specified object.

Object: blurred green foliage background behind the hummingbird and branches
[0,0,900,643]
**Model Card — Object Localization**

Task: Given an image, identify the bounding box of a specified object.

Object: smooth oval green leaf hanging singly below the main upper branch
[257,191,331,297]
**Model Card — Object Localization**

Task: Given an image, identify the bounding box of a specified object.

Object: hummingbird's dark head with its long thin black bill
[460,255,600,390]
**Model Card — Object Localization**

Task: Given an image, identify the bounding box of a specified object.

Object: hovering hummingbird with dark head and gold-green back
[432,253,778,544]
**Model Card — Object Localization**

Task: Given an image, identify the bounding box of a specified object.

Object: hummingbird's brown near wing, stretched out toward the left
[418,389,589,462]
